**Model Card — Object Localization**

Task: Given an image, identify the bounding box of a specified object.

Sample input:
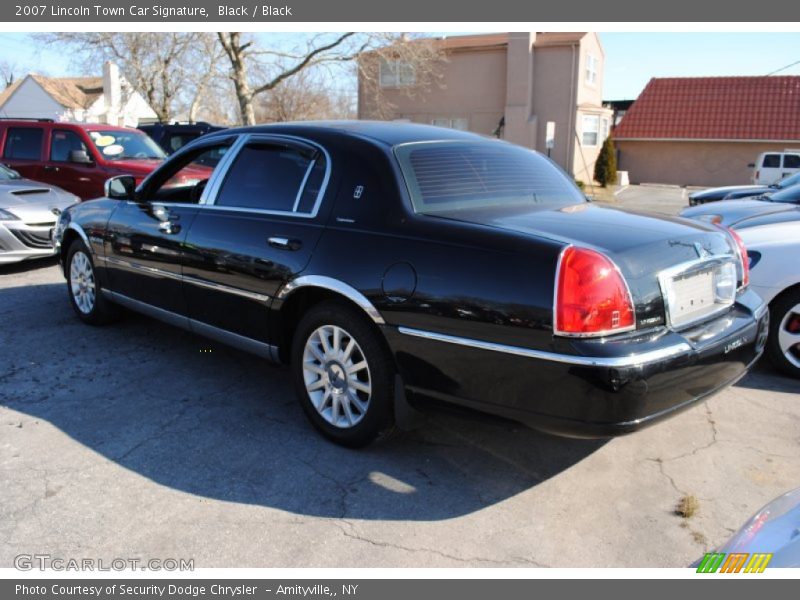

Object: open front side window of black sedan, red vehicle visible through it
[145,141,230,204]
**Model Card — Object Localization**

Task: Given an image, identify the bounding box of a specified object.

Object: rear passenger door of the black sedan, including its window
[184,135,333,342]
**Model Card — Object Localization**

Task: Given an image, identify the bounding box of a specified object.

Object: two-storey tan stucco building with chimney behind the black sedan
[358,32,612,181]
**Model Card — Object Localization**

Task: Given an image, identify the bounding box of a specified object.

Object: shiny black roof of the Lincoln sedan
[203,121,486,146]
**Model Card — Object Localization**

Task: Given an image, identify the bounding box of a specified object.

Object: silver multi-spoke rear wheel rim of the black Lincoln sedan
[303,325,372,429]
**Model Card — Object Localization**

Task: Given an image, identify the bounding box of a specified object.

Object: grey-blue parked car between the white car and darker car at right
[680,185,800,227]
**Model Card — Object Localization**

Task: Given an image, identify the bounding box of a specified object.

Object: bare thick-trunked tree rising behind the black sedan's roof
[217,32,441,125]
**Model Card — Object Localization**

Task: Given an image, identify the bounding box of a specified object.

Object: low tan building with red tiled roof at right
[614,76,800,186]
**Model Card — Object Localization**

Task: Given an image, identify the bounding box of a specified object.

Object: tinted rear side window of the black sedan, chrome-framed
[215,142,325,213]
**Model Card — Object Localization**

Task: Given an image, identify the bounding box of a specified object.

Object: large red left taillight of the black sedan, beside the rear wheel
[554,246,636,336]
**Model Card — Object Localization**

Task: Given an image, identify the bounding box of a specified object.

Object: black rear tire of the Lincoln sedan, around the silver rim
[291,300,395,448]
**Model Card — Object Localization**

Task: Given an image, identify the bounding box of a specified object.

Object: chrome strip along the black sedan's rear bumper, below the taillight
[398,327,692,369]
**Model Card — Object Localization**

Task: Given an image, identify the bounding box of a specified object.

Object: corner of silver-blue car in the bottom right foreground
[693,488,800,573]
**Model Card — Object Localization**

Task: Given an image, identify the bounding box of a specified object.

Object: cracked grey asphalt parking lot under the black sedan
[0,187,800,567]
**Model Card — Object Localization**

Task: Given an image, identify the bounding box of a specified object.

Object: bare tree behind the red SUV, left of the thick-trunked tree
[37,32,220,121]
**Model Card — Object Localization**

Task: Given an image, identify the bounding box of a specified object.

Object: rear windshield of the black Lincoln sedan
[395,141,586,213]
